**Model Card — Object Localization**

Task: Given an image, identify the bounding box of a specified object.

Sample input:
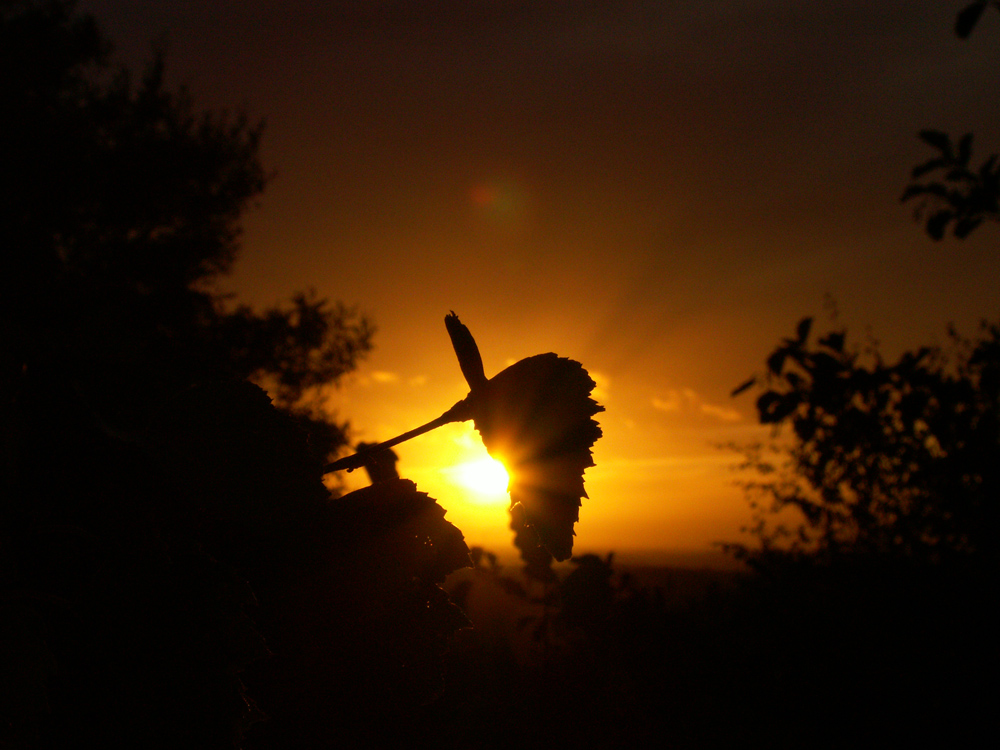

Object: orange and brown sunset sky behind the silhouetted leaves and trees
[79,0,1000,554]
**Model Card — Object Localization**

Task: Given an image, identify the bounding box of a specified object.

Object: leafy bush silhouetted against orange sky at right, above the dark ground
[736,319,1000,564]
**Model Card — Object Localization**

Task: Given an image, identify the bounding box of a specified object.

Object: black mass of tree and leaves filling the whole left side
[0,0,468,748]
